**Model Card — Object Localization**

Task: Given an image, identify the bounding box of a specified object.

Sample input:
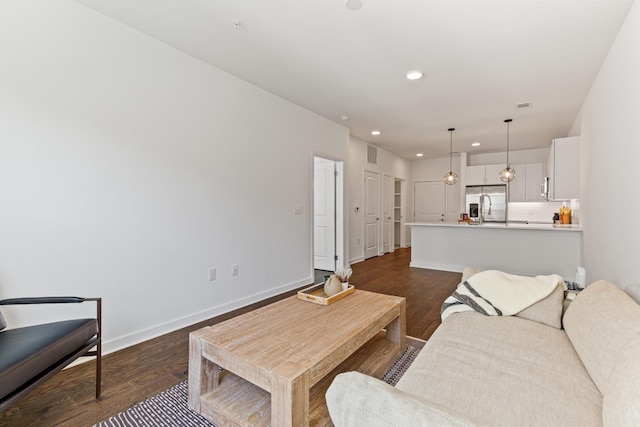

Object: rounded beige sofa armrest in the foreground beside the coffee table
[326,372,478,427]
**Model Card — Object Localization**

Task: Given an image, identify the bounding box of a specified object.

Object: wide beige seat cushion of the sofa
[397,312,602,426]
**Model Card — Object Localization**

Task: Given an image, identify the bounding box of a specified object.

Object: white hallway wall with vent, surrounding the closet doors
[346,137,412,263]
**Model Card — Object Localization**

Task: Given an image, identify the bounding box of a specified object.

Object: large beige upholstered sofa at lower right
[326,281,640,427]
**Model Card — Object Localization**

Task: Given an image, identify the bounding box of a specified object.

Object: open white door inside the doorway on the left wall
[313,157,336,271]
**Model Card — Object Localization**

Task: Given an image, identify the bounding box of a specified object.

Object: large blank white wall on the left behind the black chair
[0,0,349,352]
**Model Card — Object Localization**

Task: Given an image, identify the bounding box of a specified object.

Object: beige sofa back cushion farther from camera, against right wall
[563,280,640,393]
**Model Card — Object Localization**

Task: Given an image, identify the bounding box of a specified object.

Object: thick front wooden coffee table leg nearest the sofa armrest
[271,362,309,427]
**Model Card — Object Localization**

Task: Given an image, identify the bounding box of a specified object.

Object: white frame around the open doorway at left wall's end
[310,153,347,280]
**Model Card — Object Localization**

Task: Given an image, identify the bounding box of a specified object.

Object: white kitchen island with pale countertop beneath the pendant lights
[407,222,582,281]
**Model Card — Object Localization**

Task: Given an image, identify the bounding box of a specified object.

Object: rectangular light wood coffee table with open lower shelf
[189,290,406,427]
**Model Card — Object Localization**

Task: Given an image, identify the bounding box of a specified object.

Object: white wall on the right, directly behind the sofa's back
[577,2,640,290]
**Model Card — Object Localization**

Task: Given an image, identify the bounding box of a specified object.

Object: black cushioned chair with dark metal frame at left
[0,297,102,412]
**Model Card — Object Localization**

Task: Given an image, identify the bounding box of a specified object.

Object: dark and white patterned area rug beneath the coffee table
[94,345,420,427]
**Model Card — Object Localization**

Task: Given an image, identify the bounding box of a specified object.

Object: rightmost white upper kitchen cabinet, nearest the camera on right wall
[547,136,580,200]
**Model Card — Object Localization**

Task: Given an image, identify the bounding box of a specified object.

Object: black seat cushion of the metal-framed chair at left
[0,319,98,399]
